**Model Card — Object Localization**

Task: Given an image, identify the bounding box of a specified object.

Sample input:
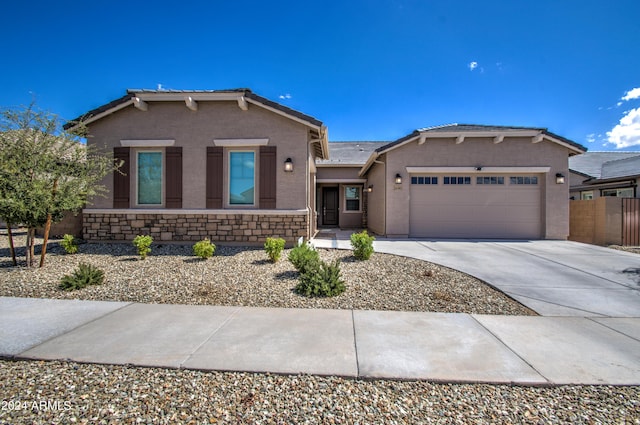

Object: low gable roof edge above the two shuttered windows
[64,88,329,158]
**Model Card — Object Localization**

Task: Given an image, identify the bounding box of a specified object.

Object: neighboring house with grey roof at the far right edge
[569,152,640,200]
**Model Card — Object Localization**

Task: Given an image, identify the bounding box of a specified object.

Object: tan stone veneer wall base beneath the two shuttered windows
[83,210,309,244]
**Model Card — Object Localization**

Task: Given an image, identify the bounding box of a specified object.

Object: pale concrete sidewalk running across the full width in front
[0,297,640,385]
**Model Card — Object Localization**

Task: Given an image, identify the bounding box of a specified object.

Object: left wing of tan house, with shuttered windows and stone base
[67,89,328,244]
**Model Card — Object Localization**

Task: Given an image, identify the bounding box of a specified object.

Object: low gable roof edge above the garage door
[360,124,587,176]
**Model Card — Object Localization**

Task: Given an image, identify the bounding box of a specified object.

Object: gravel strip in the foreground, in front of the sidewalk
[0,361,640,424]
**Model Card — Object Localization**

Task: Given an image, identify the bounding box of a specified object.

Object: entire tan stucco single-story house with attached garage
[69,89,586,244]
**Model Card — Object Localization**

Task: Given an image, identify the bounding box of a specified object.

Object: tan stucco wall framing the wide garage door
[378,138,569,239]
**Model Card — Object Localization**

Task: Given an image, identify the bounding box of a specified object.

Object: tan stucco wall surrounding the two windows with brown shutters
[87,101,310,209]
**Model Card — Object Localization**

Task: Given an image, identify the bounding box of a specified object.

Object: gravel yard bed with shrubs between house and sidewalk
[0,232,535,315]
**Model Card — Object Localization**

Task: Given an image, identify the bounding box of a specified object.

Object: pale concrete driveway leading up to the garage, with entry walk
[313,235,640,317]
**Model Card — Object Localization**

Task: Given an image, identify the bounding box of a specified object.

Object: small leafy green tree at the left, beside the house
[0,103,121,267]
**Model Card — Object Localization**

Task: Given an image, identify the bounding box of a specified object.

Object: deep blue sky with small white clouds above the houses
[0,0,640,150]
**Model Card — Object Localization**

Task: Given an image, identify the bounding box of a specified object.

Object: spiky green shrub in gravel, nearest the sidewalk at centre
[295,260,346,297]
